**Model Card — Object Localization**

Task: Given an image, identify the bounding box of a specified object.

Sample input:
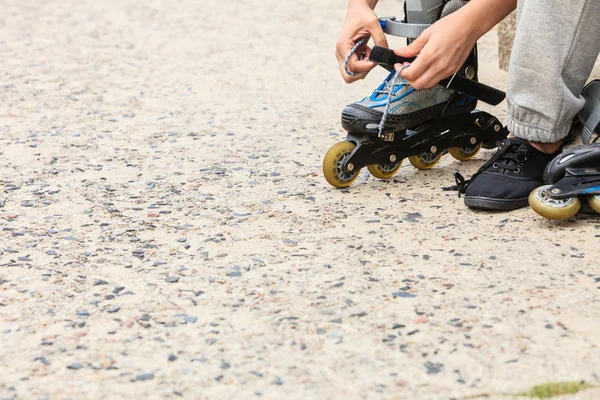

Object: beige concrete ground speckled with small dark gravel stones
[0,0,600,399]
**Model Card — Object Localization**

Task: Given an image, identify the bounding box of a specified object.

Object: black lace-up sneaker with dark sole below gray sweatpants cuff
[456,138,562,211]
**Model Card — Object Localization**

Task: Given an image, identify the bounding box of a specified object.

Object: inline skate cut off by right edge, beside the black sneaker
[529,80,600,220]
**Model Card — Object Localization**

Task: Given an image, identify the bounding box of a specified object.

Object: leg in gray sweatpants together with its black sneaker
[461,0,600,210]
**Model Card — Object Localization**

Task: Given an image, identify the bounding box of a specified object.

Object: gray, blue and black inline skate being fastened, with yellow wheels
[323,0,508,188]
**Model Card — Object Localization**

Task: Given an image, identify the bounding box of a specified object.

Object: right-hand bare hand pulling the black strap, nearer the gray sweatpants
[394,10,478,89]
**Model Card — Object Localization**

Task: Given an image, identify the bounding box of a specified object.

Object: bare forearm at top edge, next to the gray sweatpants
[458,0,517,39]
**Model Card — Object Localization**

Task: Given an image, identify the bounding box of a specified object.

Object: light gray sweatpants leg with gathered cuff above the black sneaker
[507,0,600,143]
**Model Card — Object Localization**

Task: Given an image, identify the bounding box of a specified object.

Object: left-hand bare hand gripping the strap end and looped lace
[335,1,388,83]
